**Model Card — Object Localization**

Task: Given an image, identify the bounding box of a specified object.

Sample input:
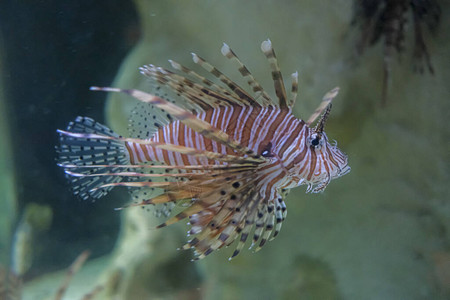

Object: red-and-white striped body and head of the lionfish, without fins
[126,106,346,192]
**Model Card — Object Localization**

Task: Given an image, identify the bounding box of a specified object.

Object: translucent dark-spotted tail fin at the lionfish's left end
[56,117,130,200]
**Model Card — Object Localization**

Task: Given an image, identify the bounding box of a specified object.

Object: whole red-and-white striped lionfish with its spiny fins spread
[57,40,350,259]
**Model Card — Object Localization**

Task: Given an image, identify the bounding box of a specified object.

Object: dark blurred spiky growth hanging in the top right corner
[351,0,441,106]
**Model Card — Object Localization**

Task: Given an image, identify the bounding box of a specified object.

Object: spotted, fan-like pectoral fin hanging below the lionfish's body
[175,173,285,259]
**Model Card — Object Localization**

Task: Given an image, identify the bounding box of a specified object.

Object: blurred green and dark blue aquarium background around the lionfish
[0,0,450,299]
